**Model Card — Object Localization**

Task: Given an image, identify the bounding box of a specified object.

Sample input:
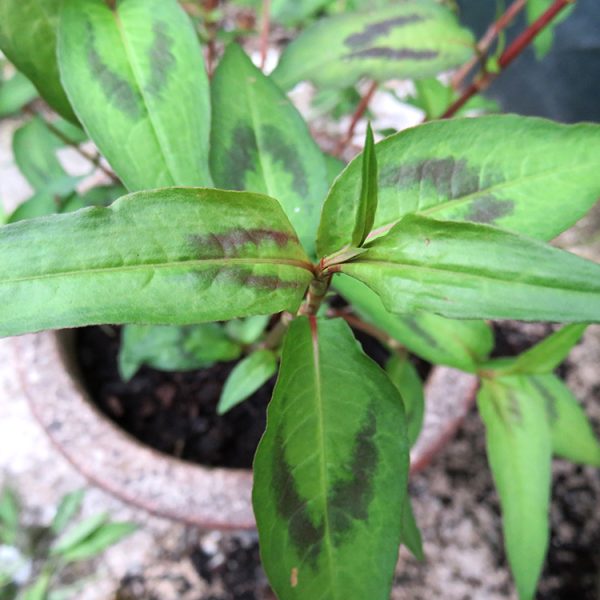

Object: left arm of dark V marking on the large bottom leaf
[273,428,325,569]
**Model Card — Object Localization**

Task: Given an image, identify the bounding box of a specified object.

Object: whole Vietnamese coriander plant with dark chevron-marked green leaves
[0,0,600,600]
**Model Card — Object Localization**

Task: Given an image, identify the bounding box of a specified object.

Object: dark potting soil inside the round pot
[77,327,274,468]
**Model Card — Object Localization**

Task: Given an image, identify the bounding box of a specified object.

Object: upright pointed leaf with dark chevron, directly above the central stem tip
[211,44,327,255]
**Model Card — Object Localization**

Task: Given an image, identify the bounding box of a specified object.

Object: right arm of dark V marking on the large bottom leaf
[328,404,379,544]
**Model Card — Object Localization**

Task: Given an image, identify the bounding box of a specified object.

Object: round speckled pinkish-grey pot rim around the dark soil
[13,332,477,529]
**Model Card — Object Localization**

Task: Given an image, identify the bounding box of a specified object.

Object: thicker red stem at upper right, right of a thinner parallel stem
[440,0,576,119]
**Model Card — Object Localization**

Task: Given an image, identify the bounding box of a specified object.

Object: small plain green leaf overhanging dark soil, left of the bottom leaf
[217,350,277,415]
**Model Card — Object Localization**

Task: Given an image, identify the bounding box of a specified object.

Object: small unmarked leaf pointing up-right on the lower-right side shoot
[494,323,587,374]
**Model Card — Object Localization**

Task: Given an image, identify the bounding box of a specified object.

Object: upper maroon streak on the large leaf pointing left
[190,228,300,258]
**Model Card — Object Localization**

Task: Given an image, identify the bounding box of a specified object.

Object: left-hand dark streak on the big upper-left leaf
[86,22,142,120]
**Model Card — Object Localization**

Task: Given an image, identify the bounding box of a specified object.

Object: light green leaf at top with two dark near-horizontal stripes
[272,0,474,89]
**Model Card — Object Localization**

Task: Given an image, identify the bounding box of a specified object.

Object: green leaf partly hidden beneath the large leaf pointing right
[333,273,494,373]
